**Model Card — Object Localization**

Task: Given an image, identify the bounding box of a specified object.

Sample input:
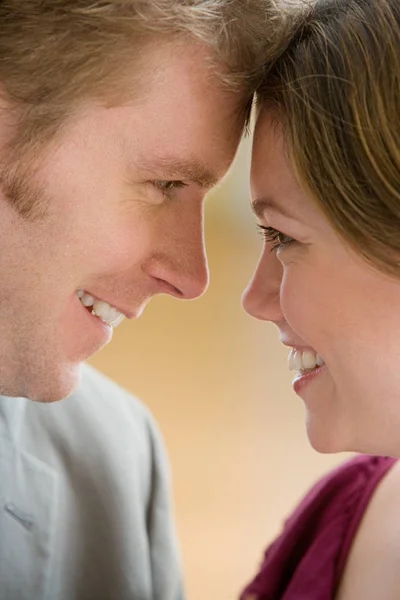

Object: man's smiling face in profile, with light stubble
[0,42,242,401]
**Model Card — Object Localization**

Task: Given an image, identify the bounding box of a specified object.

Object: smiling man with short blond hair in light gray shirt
[0,0,282,600]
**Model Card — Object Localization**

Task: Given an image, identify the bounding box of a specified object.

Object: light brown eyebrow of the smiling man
[139,156,220,189]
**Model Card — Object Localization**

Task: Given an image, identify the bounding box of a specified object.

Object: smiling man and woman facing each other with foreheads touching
[0,0,400,600]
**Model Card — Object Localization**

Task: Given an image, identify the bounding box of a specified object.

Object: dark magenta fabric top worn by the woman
[240,455,396,600]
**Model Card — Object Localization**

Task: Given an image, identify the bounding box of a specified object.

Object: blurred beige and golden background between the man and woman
[91,141,346,600]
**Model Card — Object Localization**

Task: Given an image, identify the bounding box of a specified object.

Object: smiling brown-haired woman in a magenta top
[243,0,400,600]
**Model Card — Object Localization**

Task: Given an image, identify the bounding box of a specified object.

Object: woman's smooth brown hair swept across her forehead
[258,0,400,275]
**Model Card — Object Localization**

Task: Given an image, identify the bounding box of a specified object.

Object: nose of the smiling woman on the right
[242,248,284,323]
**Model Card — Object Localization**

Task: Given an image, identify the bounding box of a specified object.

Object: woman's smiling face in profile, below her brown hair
[243,112,400,455]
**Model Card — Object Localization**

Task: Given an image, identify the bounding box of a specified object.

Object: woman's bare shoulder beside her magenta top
[335,462,400,600]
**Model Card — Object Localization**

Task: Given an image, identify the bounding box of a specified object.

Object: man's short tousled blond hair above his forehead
[0,0,279,150]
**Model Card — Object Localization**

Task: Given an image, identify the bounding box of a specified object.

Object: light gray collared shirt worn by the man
[0,366,184,600]
